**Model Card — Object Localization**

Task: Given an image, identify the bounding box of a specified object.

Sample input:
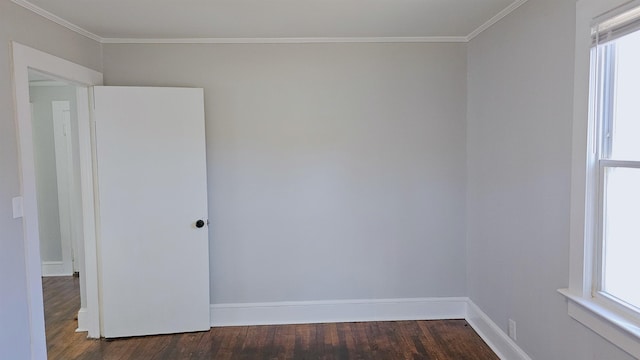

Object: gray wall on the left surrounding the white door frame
[0,0,102,359]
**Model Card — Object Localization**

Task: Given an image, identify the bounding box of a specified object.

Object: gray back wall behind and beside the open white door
[104,44,466,303]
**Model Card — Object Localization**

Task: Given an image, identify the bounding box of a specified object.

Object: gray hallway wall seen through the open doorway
[29,86,81,261]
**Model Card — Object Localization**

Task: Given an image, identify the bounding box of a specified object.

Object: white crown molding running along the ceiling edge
[11,0,527,44]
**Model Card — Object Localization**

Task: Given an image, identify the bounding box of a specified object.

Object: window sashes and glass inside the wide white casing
[591,16,640,320]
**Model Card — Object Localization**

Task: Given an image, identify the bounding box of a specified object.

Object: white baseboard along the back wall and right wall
[210,297,531,360]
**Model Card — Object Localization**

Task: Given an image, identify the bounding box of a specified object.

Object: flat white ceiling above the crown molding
[12,0,526,40]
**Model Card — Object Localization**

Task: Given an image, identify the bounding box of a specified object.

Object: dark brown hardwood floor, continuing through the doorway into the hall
[43,277,498,360]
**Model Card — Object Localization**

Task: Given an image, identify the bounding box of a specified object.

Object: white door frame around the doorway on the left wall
[11,41,102,359]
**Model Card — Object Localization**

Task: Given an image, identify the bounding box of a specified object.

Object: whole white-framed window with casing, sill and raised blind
[559,0,640,358]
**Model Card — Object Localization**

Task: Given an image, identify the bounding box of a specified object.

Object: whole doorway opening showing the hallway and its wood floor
[28,69,87,349]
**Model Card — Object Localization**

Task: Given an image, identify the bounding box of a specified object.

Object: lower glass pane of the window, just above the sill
[602,168,640,308]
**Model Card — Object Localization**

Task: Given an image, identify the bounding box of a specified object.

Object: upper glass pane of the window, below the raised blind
[610,31,640,160]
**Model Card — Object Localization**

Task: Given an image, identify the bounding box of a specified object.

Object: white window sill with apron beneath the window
[558,289,640,358]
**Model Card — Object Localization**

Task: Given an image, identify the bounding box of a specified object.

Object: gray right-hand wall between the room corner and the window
[467,0,630,360]
